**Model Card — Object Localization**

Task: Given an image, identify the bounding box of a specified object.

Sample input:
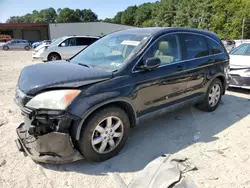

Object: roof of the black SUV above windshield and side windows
[113,27,220,40]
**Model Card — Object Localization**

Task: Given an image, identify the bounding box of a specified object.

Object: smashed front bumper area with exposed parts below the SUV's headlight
[16,108,83,164]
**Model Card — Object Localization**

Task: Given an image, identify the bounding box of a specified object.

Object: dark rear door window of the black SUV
[183,34,209,59]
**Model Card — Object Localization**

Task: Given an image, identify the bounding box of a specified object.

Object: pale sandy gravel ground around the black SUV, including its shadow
[0,51,250,188]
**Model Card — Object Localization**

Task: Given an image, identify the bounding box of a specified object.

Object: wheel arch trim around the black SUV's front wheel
[71,99,137,141]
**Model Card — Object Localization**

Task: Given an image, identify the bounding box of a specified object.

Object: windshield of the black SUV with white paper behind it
[71,32,151,71]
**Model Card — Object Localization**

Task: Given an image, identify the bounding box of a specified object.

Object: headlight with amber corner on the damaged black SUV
[26,90,80,110]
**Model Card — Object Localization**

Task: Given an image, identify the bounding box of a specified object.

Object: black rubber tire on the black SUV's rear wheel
[197,78,223,112]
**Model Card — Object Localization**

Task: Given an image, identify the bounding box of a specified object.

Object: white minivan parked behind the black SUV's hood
[32,36,99,61]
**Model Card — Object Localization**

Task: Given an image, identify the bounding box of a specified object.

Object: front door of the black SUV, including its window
[133,34,187,116]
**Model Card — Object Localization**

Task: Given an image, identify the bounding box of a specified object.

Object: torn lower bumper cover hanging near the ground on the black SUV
[16,123,83,164]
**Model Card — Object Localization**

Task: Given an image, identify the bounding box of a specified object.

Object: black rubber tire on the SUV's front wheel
[78,107,130,162]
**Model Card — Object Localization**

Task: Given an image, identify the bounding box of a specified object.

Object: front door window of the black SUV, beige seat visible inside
[143,35,181,65]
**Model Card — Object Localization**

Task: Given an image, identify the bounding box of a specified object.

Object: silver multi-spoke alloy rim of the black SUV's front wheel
[91,116,124,154]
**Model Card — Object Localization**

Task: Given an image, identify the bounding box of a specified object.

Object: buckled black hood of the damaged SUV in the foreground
[18,61,113,96]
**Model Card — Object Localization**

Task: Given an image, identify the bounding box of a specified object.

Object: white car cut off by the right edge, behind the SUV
[229,43,250,89]
